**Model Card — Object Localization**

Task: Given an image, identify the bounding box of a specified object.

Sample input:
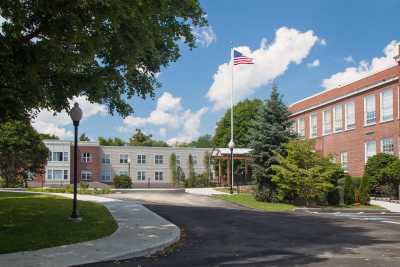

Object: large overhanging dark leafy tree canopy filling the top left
[0,0,207,120]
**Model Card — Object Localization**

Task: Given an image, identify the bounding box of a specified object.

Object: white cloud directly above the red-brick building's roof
[322,40,400,89]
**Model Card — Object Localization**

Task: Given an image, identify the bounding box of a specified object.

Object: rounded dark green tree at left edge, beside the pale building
[0,121,48,186]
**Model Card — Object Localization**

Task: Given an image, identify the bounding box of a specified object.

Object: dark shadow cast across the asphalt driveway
[83,204,400,267]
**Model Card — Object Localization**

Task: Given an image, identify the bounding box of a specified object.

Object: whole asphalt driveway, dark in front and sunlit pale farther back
[80,194,400,267]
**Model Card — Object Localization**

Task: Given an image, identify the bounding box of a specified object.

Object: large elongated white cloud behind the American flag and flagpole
[206,27,319,110]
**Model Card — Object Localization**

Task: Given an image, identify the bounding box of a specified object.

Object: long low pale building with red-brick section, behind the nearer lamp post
[35,140,211,187]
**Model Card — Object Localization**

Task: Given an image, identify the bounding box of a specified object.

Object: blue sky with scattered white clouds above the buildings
[34,0,400,142]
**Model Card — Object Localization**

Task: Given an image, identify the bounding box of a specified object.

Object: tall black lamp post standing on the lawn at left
[70,103,82,221]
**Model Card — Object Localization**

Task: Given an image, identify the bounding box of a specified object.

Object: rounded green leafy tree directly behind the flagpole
[213,99,263,147]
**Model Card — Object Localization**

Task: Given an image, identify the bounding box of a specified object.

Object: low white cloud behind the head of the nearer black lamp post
[32,96,107,139]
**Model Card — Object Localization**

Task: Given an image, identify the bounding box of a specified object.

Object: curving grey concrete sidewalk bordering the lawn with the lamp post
[0,193,180,267]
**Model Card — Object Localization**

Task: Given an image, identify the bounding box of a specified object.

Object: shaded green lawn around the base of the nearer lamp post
[0,192,117,253]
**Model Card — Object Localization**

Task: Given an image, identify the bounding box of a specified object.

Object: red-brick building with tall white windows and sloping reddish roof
[289,46,400,176]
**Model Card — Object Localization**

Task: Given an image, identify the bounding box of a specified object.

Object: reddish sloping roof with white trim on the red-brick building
[289,65,400,116]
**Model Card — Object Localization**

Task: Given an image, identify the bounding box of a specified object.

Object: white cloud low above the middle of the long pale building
[119,92,208,144]
